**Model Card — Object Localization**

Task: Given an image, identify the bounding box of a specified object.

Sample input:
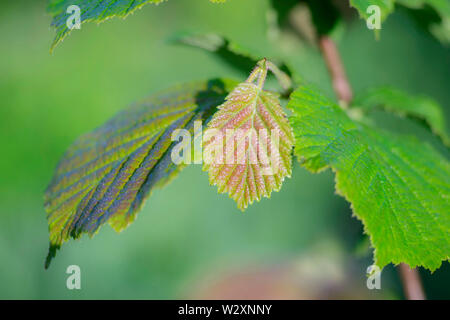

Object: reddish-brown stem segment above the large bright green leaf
[319,35,353,104]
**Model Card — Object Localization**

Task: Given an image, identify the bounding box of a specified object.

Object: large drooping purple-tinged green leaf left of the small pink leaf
[45,80,235,267]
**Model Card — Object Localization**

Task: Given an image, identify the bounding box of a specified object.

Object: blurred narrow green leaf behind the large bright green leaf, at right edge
[352,87,450,146]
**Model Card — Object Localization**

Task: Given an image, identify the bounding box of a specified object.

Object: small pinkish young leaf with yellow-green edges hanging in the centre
[203,60,294,210]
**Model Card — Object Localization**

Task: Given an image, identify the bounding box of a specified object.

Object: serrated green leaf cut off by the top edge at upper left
[47,0,226,50]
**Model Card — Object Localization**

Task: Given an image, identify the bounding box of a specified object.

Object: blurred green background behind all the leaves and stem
[0,0,450,299]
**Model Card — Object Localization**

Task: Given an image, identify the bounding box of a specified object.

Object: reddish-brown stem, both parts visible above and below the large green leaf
[319,35,425,300]
